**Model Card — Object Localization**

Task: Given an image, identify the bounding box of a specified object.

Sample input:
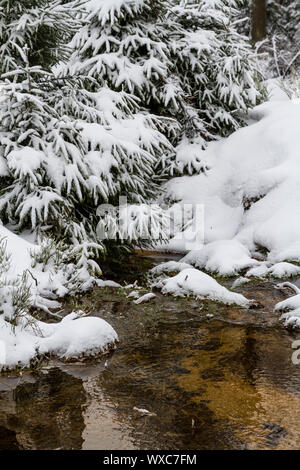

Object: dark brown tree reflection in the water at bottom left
[0,368,86,449]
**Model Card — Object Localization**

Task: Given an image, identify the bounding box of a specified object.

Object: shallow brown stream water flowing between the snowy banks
[0,258,300,450]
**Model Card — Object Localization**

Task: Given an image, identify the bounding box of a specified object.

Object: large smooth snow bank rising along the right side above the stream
[166,100,300,275]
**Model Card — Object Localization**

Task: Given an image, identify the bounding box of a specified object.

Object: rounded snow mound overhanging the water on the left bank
[0,312,118,370]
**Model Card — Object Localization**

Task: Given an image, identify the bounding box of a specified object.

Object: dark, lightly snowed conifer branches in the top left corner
[0,0,80,73]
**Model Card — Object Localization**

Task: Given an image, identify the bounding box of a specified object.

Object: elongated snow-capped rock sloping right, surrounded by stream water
[156,268,250,307]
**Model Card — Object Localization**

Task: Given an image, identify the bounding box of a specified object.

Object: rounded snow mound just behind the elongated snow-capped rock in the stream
[181,240,259,276]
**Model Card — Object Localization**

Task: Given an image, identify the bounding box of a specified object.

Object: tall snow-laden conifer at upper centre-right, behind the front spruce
[69,0,259,171]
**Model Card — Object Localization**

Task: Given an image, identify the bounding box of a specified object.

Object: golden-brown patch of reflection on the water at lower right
[178,328,300,449]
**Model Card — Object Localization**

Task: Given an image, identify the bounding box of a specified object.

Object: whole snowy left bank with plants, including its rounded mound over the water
[0,226,120,370]
